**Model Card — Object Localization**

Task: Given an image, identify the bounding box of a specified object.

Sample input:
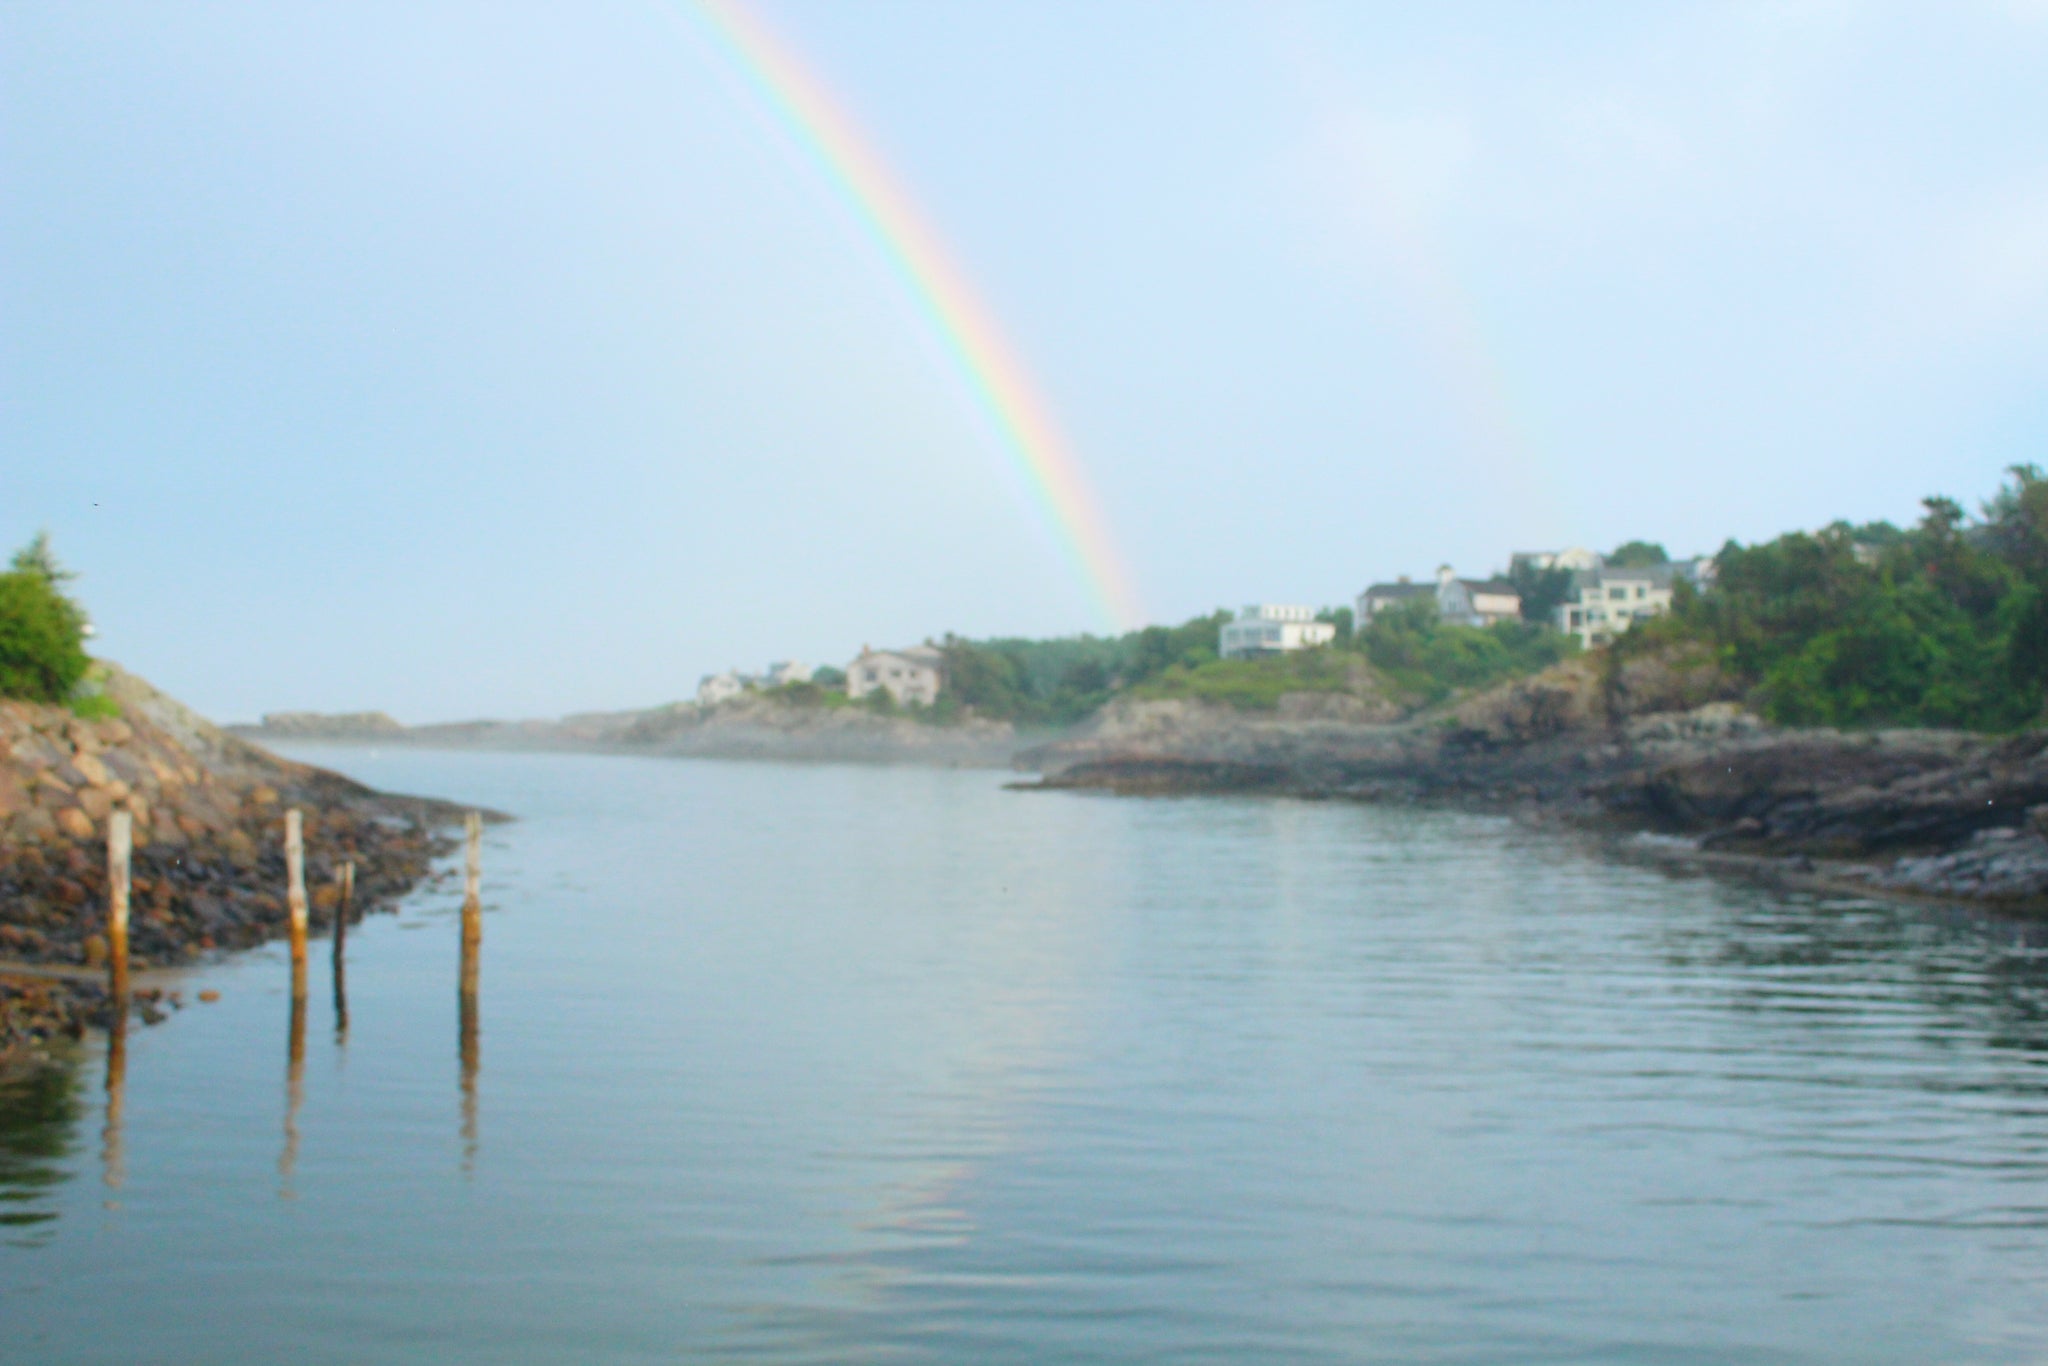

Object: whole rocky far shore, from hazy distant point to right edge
[233,688,2048,911]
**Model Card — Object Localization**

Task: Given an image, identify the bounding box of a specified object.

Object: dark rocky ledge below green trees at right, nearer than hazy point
[1020,664,2048,909]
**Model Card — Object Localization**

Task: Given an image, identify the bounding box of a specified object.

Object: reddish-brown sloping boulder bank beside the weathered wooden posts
[0,670,479,1059]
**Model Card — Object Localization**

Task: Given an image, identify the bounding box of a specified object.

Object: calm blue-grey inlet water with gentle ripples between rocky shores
[0,750,2048,1364]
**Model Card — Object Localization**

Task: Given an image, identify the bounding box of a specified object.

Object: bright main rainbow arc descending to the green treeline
[690,0,1143,629]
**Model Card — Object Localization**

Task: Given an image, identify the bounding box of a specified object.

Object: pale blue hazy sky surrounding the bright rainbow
[0,0,2048,723]
